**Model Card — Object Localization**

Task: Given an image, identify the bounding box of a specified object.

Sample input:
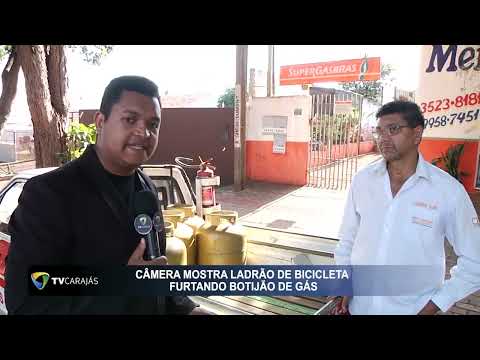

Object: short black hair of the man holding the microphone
[100,76,161,118]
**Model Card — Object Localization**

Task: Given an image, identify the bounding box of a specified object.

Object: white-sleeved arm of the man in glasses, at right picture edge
[431,186,480,312]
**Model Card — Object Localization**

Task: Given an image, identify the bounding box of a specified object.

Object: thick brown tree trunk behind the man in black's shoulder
[17,45,68,167]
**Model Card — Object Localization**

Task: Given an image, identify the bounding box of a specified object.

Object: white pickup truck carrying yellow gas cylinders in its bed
[0,164,336,315]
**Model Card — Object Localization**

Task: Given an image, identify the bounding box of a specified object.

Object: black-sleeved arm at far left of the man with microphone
[5,180,71,314]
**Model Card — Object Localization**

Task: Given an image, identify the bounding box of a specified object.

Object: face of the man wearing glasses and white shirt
[376,114,423,161]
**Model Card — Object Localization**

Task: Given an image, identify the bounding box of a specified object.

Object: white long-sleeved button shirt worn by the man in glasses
[335,154,480,314]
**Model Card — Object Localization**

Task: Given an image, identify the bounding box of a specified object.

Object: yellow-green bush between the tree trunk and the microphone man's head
[60,123,97,163]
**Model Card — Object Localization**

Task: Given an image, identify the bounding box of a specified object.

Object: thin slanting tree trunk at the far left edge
[0,47,20,130]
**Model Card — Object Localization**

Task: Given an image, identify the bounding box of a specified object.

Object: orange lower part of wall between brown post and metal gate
[247,140,308,185]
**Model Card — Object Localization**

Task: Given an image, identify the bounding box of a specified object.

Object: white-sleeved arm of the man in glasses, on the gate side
[334,178,360,265]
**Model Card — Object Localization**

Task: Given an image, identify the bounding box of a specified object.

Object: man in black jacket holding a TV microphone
[5,76,207,314]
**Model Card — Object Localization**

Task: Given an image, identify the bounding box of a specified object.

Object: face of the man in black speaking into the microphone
[95,91,160,172]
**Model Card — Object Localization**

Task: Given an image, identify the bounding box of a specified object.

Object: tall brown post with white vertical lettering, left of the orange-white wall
[233,45,248,191]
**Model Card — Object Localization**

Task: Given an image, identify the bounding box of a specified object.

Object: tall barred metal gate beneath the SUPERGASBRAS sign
[307,88,363,190]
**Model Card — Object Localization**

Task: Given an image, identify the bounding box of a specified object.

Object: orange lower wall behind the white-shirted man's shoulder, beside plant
[419,139,479,192]
